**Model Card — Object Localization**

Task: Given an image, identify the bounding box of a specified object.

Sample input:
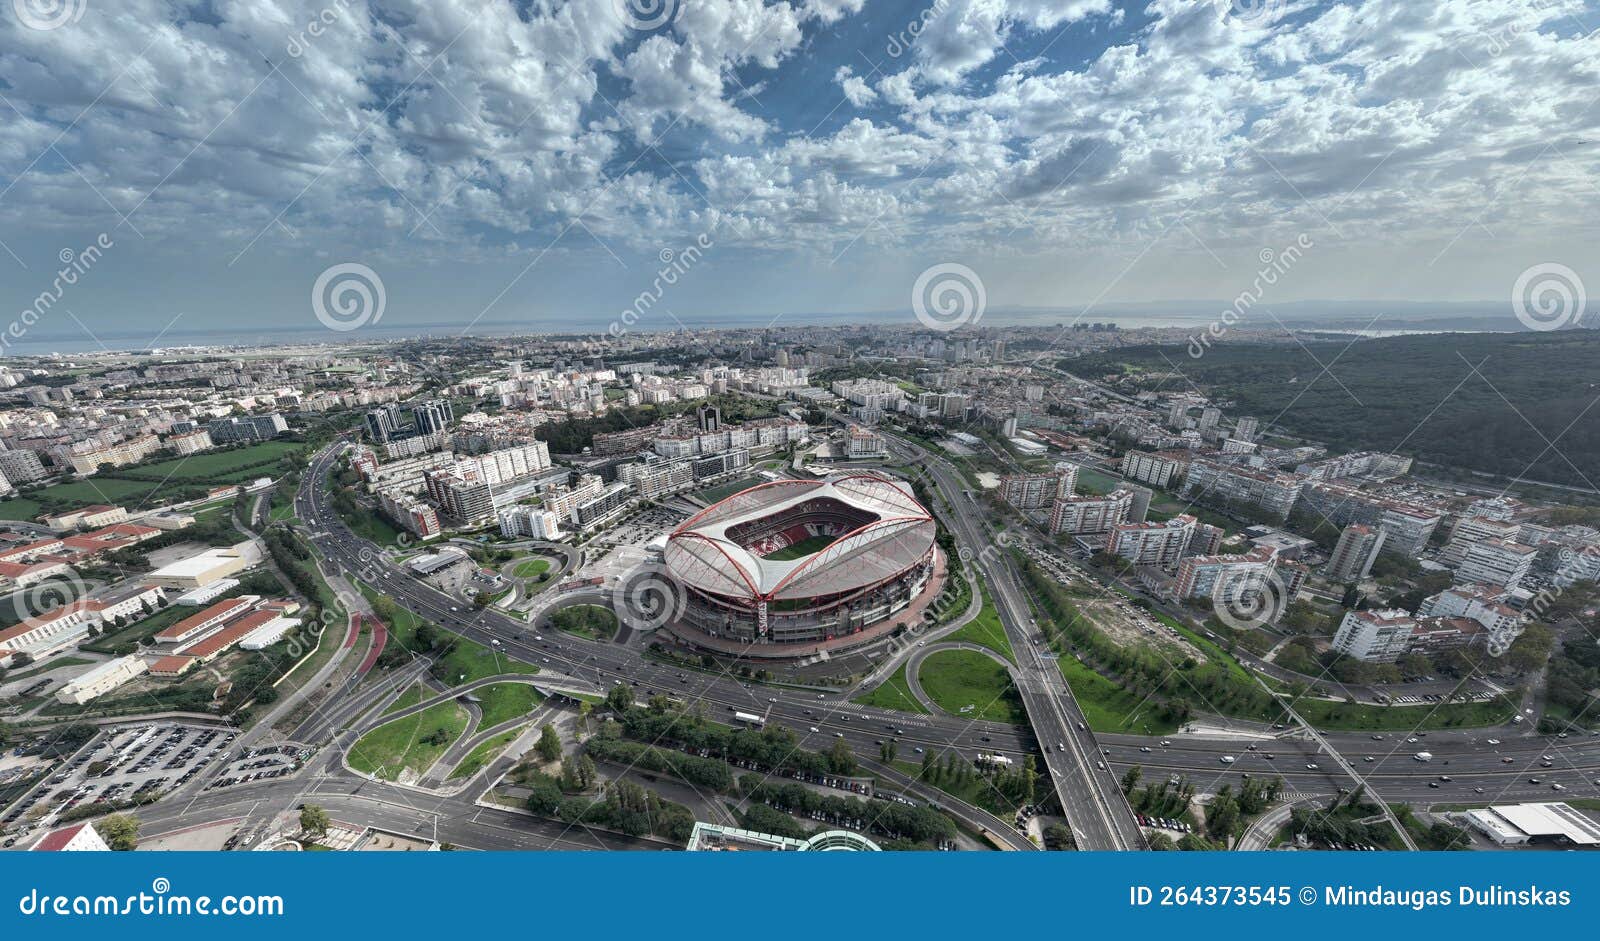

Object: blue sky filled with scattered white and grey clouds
[0,0,1600,345]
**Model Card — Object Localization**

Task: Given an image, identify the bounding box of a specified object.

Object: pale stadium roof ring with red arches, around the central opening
[666,474,934,602]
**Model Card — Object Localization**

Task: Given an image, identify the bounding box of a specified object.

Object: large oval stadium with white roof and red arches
[664,474,942,656]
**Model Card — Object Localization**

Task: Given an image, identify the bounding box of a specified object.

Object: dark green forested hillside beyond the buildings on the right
[1059,331,1600,488]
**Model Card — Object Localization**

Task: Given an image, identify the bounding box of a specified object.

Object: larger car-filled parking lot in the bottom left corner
[0,723,238,840]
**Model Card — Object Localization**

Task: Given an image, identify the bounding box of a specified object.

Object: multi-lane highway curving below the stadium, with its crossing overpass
[262,440,1600,848]
